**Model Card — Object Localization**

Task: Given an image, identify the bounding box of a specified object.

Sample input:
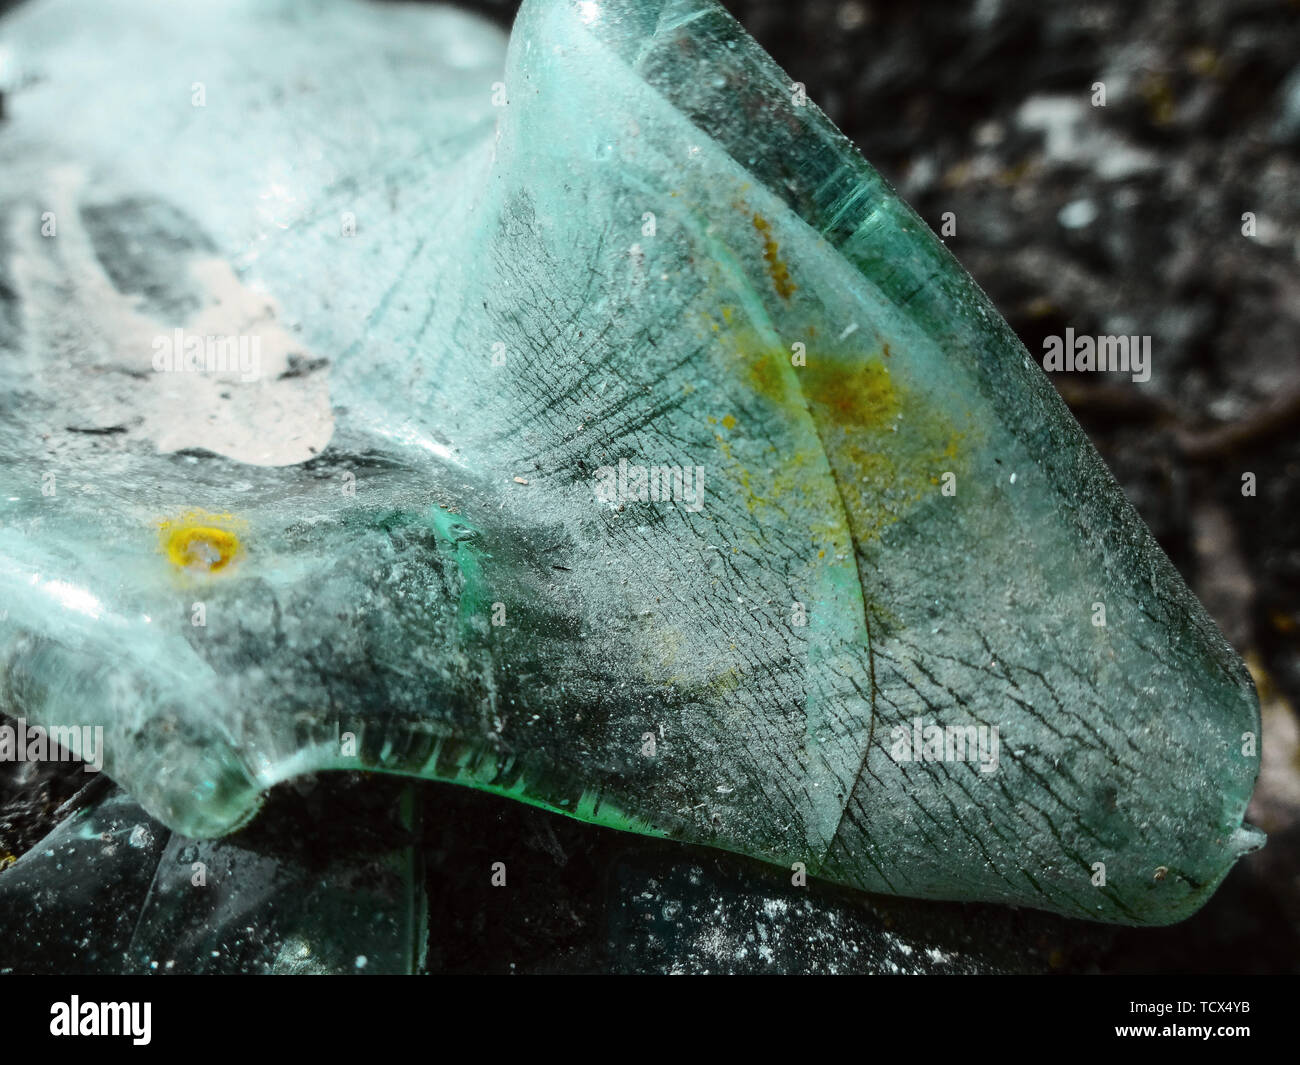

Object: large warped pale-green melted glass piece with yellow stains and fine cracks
[0,0,1258,923]
